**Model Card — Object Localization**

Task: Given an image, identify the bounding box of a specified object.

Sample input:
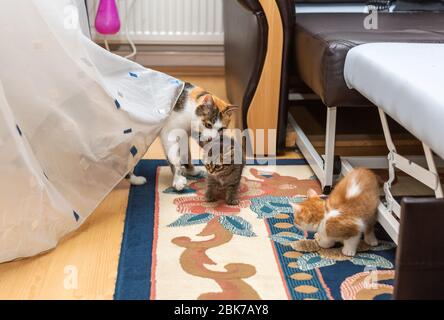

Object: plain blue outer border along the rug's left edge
[114,159,308,300]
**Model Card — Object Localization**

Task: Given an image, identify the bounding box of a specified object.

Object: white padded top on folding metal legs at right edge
[344,43,444,158]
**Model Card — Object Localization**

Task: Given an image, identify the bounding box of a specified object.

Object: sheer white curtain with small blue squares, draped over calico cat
[0,0,183,262]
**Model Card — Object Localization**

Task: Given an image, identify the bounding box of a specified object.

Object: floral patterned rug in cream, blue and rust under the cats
[114,159,395,300]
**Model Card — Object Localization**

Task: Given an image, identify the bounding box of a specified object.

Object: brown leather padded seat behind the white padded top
[293,12,444,107]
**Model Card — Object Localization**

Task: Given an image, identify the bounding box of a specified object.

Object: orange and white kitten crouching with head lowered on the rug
[291,168,379,256]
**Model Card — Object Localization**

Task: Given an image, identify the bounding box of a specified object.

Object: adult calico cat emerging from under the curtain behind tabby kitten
[129,82,237,191]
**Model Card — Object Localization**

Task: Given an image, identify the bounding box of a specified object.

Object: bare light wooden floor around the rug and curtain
[0,71,296,299]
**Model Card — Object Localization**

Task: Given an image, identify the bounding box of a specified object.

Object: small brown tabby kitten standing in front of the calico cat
[201,135,245,205]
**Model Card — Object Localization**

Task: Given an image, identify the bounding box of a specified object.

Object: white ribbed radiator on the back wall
[87,0,224,45]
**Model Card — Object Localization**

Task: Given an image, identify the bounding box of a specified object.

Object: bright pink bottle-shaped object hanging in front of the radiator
[95,0,120,34]
